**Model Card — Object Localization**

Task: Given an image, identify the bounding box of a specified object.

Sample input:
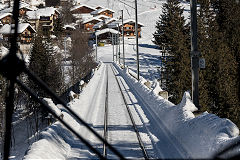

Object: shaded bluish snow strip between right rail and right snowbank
[112,62,191,159]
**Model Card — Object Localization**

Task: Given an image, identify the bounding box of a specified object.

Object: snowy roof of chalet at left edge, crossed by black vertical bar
[0,23,36,34]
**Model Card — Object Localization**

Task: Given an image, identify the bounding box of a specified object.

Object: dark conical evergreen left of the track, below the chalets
[29,33,62,97]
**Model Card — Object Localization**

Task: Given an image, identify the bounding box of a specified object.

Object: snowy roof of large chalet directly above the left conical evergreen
[26,7,58,19]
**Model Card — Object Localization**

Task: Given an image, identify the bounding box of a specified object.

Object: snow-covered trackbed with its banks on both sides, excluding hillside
[25,59,239,159]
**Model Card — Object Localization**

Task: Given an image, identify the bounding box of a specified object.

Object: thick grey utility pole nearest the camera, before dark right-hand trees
[190,0,200,109]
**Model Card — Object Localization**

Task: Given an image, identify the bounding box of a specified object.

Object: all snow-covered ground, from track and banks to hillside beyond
[6,0,239,159]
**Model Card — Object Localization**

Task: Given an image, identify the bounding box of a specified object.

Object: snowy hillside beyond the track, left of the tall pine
[82,0,190,81]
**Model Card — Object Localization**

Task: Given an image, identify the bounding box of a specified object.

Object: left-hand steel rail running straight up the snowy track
[103,66,108,158]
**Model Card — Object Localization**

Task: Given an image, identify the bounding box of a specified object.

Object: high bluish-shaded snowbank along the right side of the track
[115,62,239,158]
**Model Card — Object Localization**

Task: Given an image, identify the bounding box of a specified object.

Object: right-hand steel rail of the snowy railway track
[111,65,149,159]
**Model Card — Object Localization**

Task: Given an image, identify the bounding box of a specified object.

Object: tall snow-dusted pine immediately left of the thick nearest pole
[154,0,191,103]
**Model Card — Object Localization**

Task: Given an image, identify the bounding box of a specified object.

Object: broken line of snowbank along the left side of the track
[23,65,103,160]
